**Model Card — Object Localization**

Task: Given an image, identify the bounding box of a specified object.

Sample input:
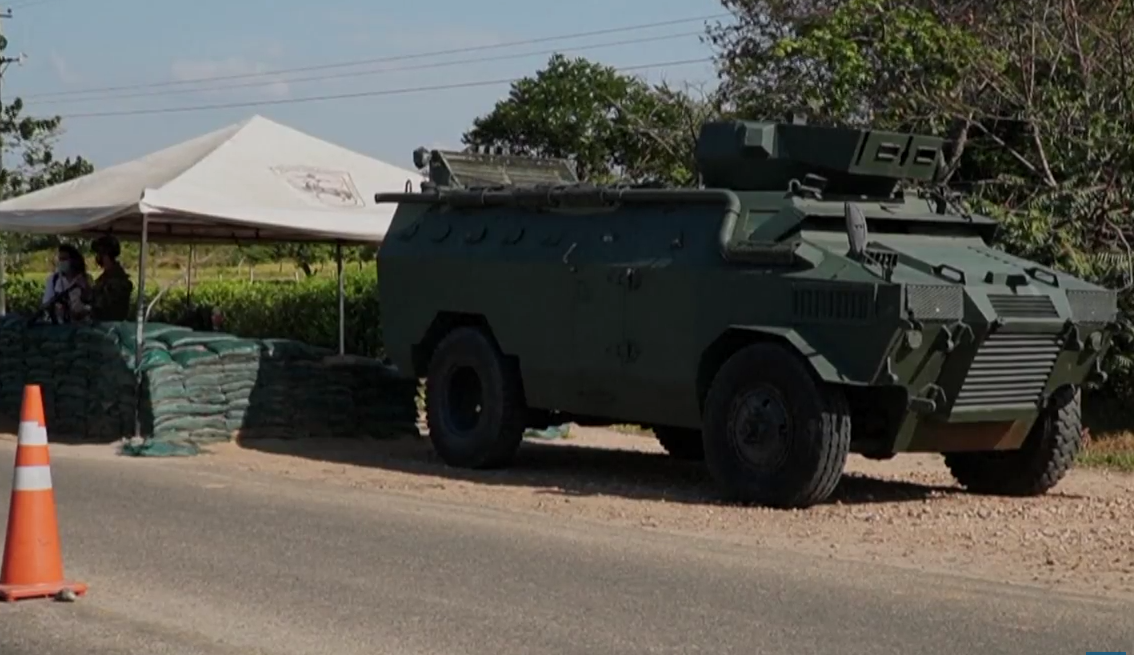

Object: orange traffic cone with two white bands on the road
[0,384,86,601]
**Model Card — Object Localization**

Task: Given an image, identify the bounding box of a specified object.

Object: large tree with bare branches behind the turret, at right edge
[708,0,1134,388]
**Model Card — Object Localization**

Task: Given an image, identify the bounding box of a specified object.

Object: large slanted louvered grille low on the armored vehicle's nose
[953,333,1061,409]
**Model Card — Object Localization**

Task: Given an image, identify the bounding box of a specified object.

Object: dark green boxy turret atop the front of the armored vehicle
[695,120,945,197]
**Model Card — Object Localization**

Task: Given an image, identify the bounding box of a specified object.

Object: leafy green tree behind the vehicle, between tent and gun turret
[463,54,712,184]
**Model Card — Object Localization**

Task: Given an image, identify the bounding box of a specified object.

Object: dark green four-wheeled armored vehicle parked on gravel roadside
[375,122,1117,507]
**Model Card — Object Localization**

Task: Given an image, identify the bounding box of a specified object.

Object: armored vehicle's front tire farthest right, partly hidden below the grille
[945,386,1083,496]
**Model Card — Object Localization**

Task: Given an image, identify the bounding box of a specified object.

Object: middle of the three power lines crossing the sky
[37,32,700,104]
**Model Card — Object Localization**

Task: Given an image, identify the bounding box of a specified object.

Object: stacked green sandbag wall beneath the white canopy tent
[0,318,417,456]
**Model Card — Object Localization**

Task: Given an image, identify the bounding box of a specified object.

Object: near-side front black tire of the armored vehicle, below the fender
[703,343,851,508]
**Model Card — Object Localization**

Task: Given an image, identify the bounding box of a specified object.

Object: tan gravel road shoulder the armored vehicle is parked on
[2,427,1134,598]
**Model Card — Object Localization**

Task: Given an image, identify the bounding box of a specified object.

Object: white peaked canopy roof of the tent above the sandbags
[0,116,422,243]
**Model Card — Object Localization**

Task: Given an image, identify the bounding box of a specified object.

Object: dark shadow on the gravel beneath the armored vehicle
[240,430,984,504]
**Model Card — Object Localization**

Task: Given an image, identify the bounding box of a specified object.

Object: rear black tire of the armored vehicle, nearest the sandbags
[425,328,526,468]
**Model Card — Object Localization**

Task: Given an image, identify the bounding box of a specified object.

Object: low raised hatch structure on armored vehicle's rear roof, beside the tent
[414,147,578,189]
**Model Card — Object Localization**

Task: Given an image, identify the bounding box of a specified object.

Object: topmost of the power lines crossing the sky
[24,12,731,101]
